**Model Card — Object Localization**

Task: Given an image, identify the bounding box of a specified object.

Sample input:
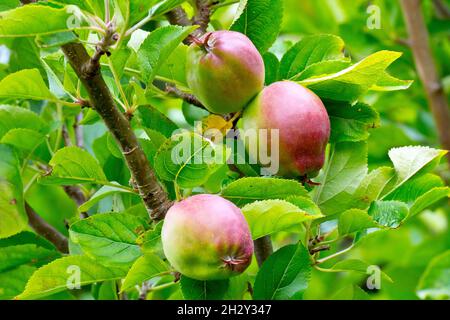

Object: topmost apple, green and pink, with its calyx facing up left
[186,31,265,114]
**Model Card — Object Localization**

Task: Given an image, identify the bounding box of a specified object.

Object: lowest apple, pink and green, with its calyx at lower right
[161,194,253,280]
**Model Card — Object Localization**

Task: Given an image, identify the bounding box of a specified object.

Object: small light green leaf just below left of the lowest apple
[120,254,169,292]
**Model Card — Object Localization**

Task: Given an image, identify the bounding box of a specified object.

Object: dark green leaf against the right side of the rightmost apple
[327,103,380,143]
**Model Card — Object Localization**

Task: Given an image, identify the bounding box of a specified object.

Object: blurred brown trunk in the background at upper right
[400,0,450,164]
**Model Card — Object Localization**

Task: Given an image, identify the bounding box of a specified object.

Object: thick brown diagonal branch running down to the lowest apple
[62,43,172,220]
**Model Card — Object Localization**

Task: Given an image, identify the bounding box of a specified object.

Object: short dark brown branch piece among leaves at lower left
[25,202,69,253]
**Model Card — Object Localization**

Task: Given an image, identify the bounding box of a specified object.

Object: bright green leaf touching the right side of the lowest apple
[242,200,322,239]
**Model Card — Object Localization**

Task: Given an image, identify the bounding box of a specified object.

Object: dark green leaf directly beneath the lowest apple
[180,276,229,300]
